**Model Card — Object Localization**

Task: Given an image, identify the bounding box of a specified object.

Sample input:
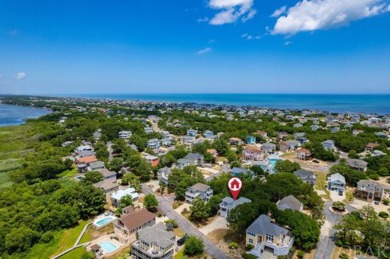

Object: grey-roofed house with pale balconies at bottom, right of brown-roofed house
[131,222,176,259]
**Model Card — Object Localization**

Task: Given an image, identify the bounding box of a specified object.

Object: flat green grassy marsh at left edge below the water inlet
[0,124,32,189]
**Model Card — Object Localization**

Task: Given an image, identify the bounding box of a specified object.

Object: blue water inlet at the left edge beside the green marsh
[0,103,50,127]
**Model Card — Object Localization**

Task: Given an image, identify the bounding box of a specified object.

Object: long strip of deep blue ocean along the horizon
[78,94,390,114]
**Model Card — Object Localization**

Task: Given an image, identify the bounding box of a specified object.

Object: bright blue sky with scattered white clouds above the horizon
[0,0,390,94]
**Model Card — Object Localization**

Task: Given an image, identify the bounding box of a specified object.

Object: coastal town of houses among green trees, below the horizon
[0,96,390,259]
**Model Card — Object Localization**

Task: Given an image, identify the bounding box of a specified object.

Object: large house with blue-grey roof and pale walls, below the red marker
[246,214,294,258]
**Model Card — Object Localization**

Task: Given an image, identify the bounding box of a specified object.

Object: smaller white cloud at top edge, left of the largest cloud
[208,0,256,25]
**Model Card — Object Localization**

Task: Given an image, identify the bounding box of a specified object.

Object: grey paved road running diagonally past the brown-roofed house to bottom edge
[142,184,230,259]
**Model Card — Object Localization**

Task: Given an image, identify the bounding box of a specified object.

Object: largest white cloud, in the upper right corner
[272,0,390,34]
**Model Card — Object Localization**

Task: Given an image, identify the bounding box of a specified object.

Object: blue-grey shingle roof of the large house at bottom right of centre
[246,214,288,236]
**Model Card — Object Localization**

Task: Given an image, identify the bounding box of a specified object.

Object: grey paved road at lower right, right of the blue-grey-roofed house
[314,201,356,259]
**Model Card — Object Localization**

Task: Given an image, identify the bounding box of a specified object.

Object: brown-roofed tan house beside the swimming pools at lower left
[114,209,156,243]
